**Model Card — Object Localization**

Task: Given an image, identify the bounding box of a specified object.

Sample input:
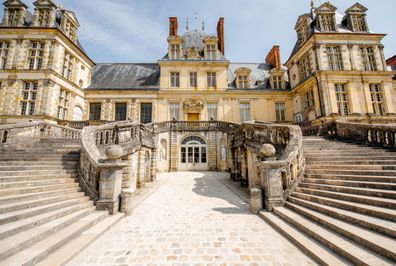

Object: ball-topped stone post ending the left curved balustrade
[96,145,125,214]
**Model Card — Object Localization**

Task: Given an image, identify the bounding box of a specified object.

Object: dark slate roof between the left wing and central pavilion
[88,63,160,90]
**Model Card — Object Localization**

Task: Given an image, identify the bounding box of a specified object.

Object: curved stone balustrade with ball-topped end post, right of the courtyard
[232,121,305,213]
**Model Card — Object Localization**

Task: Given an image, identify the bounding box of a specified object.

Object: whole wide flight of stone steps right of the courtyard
[260,137,396,265]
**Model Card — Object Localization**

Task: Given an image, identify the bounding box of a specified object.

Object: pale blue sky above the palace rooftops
[1,0,396,63]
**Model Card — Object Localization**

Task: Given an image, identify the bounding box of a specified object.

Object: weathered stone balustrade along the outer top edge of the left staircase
[0,121,81,148]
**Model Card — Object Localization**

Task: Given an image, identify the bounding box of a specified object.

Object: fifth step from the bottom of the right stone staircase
[292,192,396,222]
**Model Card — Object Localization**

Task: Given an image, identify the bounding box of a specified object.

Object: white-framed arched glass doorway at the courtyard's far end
[180,136,209,171]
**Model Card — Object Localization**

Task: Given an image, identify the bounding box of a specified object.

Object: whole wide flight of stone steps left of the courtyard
[0,139,123,265]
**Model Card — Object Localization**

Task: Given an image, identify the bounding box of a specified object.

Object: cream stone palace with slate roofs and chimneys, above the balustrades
[0,0,396,123]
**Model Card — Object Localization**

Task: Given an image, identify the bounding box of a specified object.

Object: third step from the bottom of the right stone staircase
[286,202,396,261]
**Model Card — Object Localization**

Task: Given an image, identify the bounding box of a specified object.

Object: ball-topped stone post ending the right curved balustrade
[259,144,284,211]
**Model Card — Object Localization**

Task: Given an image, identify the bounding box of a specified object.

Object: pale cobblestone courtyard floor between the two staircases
[68,172,314,266]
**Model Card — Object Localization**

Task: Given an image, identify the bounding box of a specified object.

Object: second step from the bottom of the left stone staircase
[0,211,108,265]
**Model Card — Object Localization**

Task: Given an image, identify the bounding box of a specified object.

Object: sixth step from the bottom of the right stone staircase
[295,186,396,209]
